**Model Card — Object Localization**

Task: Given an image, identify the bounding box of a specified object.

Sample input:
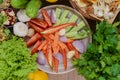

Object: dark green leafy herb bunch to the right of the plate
[73,21,120,80]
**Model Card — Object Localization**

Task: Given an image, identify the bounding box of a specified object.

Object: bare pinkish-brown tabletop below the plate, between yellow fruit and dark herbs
[49,70,85,80]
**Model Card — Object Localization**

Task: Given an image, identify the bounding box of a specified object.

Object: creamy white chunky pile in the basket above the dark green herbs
[93,0,114,20]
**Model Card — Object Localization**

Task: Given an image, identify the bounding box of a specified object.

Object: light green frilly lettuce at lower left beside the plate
[0,36,37,80]
